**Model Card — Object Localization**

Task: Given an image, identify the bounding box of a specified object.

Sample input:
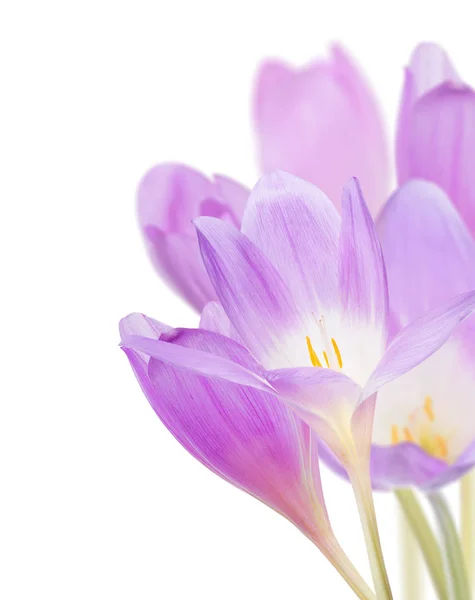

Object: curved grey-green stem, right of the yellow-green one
[428,492,470,600]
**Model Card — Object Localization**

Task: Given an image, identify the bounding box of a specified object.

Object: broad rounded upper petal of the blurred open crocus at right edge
[377,180,475,324]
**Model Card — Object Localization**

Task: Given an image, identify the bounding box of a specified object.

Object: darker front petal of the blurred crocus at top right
[399,83,475,233]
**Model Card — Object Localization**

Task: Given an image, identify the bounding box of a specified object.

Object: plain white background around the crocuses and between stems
[0,0,468,600]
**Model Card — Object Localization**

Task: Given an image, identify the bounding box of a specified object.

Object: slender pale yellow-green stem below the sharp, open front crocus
[348,468,393,600]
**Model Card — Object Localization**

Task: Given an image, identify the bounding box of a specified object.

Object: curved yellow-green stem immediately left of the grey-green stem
[395,489,449,600]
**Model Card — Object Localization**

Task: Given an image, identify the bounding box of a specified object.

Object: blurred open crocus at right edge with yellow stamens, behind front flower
[372,181,475,488]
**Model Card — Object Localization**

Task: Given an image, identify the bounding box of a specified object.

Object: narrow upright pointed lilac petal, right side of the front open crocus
[340,178,388,328]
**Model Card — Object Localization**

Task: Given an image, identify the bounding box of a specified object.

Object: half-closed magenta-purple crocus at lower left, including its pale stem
[120,310,374,599]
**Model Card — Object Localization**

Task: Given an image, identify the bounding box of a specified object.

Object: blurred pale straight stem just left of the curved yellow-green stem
[398,500,424,600]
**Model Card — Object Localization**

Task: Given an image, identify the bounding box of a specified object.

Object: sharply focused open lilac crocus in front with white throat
[122,173,475,597]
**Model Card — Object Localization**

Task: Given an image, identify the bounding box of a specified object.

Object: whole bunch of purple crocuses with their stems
[120,44,475,600]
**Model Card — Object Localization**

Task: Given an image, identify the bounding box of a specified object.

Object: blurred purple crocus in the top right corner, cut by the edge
[397,44,475,235]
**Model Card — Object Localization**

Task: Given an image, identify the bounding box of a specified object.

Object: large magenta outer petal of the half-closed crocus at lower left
[122,331,326,541]
